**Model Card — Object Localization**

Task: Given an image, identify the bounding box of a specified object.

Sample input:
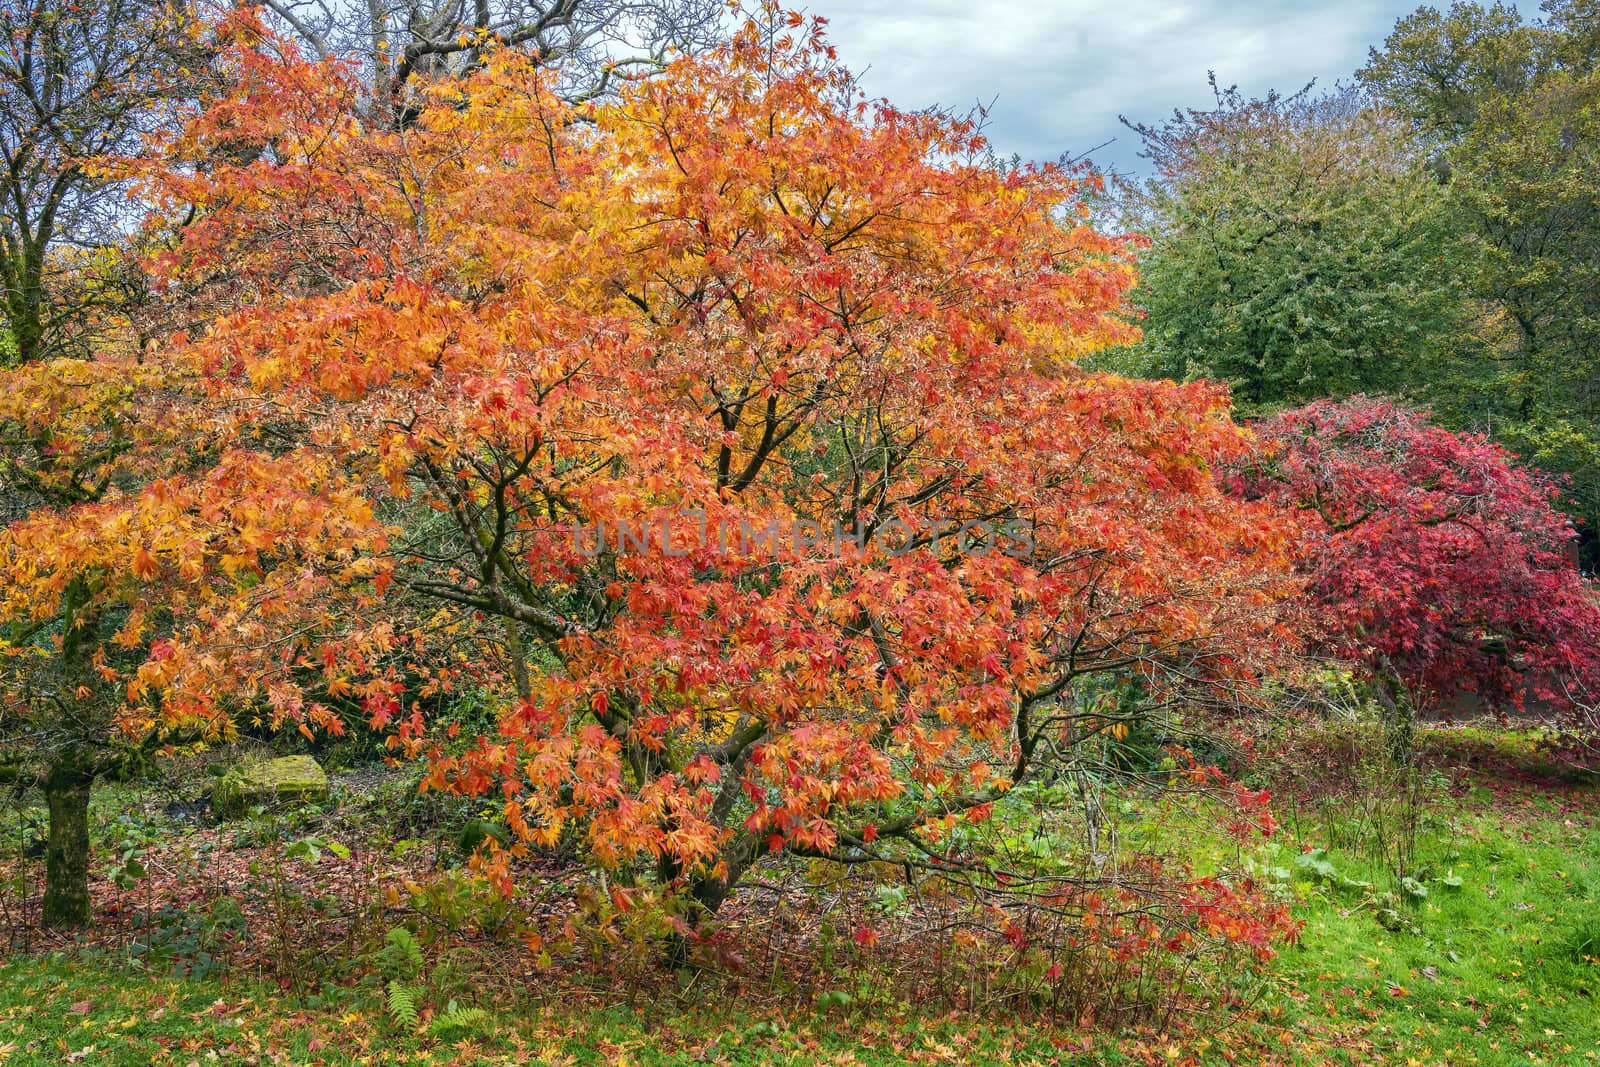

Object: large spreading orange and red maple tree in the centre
[131,8,1290,927]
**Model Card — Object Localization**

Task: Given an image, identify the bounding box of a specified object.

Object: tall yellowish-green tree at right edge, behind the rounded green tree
[1360,0,1600,559]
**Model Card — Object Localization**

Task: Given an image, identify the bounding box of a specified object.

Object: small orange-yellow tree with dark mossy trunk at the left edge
[0,354,396,926]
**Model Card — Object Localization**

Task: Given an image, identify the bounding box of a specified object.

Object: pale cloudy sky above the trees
[806,0,1421,170]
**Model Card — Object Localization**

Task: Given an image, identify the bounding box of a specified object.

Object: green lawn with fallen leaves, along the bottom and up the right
[0,751,1600,1067]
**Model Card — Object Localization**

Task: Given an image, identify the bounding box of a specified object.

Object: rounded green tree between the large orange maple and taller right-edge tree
[1120,77,1464,410]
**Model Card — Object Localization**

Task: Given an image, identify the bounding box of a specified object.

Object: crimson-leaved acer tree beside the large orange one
[1238,397,1600,752]
